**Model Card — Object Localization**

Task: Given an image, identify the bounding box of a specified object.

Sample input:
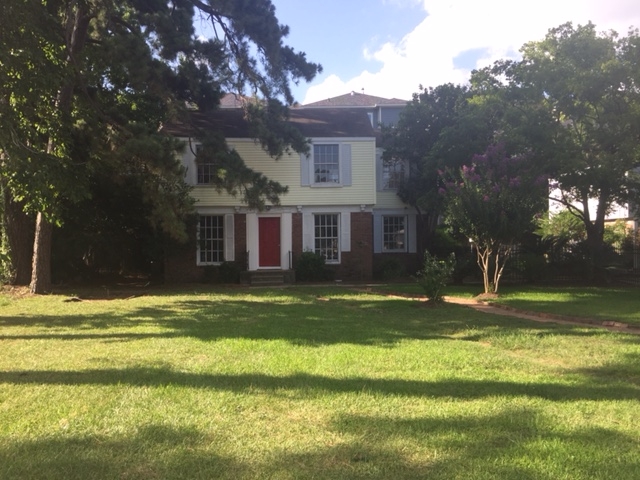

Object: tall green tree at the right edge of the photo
[495,23,640,275]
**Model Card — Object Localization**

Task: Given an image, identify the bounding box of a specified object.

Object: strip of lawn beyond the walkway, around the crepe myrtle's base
[376,282,640,326]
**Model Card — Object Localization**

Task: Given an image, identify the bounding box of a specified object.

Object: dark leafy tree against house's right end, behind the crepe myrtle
[384,75,550,255]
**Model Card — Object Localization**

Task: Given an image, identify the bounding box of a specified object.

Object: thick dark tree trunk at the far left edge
[4,189,34,285]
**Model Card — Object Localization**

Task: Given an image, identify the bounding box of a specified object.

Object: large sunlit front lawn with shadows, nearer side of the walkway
[0,287,640,480]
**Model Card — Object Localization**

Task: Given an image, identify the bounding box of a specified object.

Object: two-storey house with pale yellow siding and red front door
[165,92,417,282]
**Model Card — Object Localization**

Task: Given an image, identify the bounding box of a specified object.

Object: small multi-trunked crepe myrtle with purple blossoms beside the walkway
[440,145,547,295]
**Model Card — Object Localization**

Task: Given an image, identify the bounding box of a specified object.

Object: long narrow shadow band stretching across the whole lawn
[0,368,640,402]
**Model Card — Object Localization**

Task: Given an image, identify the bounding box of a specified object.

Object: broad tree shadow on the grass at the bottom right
[308,409,640,480]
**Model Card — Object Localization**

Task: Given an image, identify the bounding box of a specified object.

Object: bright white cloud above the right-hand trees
[303,0,640,103]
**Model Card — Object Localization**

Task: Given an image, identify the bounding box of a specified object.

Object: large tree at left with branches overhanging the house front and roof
[0,0,321,293]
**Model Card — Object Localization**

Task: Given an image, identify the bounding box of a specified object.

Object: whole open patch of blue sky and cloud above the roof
[272,0,640,103]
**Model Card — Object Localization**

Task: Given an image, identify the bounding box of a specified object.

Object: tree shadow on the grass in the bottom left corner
[0,425,248,480]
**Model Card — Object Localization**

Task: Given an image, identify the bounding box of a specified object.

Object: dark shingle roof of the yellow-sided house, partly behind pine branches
[163,108,375,138]
